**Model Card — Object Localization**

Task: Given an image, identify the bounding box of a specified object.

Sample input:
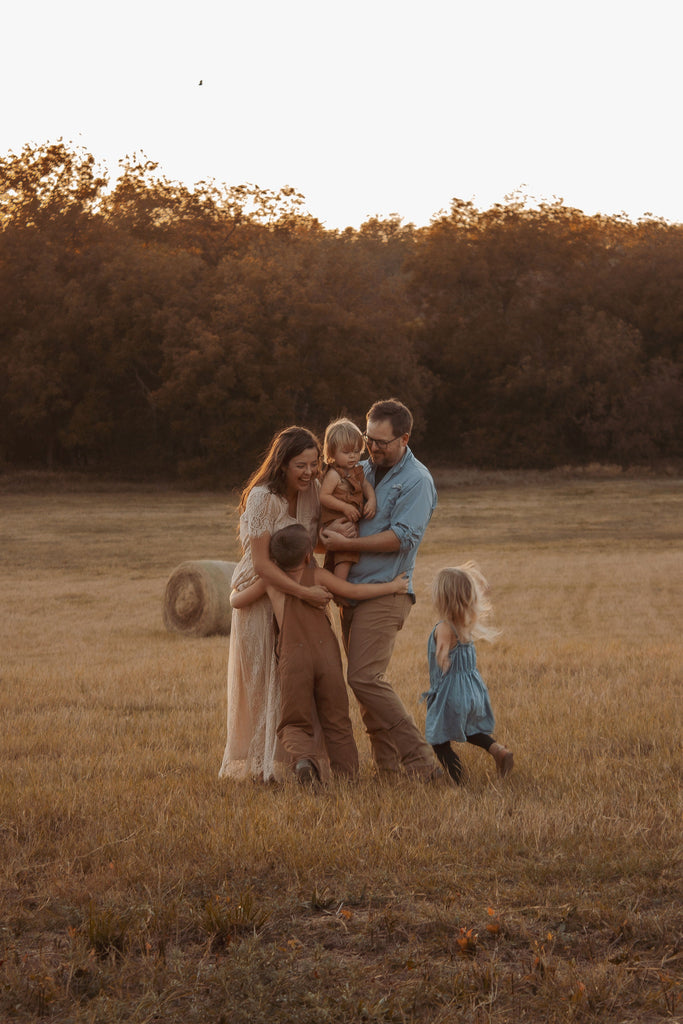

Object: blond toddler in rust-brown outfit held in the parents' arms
[321,420,377,580]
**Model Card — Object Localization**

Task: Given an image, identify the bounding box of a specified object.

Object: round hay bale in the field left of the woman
[164,559,236,637]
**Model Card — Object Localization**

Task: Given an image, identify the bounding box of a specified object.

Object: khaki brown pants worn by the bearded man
[340,594,436,776]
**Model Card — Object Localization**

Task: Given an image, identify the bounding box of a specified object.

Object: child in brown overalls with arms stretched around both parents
[230,523,408,782]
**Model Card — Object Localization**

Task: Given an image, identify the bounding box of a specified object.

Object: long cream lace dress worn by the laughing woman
[219,480,319,781]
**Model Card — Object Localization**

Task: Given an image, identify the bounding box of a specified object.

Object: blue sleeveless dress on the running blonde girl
[422,623,496,743]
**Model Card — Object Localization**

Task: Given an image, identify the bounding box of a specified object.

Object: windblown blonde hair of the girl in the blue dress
[432,562,501,643]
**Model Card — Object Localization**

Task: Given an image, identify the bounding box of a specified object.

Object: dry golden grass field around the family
[0,473,683,1024]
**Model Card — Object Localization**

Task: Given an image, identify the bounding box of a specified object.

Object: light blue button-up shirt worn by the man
[348,447,437,600]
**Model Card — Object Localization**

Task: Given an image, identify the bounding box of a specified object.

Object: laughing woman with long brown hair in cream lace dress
[219,427,332,781]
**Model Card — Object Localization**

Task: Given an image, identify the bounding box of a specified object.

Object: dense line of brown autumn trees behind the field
[0,142,683,484]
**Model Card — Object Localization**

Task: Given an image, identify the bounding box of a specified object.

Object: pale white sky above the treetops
[0,0,683,227]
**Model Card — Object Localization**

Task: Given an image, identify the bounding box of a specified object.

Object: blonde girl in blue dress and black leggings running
[422,562,513,782]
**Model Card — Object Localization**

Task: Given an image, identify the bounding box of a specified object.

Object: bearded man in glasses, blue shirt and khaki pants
[321,398,443,780]
